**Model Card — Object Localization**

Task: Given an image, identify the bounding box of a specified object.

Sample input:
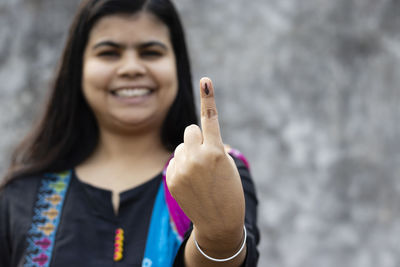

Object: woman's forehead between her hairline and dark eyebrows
[89,12,170,43]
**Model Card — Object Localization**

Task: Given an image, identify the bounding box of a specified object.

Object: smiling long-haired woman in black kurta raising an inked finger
[0,0,259,267]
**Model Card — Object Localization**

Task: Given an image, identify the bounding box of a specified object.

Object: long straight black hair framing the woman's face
[3,0,197,185]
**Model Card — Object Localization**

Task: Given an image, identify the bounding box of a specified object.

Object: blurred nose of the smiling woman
[118,52,146,78]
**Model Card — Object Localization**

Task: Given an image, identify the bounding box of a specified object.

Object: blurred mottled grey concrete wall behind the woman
[0,0,400,267]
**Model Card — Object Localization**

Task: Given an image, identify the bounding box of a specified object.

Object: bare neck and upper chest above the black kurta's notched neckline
[77,127,171,212]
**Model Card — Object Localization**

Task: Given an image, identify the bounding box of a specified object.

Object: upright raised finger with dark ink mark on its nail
[200,77,222,146]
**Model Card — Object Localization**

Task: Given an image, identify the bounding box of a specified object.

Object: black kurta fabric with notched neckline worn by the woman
[0,159,259,267]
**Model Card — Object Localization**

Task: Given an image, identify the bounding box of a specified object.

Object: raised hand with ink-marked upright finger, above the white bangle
[167,78,245,253]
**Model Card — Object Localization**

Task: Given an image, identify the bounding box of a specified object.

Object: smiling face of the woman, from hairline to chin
[82,12,178,134]
